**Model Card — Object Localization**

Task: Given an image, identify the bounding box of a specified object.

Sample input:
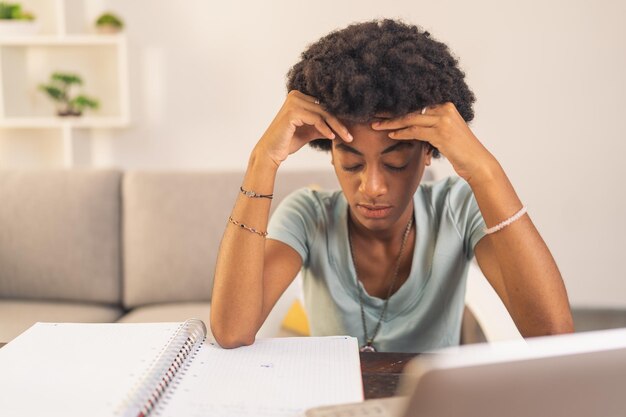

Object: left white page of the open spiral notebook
[0,323,180,417]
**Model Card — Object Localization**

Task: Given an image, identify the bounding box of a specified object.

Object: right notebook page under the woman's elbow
[157,336,363,417]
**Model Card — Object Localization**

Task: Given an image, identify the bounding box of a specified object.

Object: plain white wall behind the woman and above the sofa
[90,0,626,307]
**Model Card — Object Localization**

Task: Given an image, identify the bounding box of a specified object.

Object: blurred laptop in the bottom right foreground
[306,328,626,417]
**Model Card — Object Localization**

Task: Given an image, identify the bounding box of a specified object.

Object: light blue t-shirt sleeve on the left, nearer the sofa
[267,188,321,266]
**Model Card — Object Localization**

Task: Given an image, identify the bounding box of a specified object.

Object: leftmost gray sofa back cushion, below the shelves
[0,170,121,304]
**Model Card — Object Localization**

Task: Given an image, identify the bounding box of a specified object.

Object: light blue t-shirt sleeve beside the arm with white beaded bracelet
[448,178,485,259]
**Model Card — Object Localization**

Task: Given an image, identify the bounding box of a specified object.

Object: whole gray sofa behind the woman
[0,168,337,342]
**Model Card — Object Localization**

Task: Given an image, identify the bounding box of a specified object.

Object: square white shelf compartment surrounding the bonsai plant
[0,35,128,119]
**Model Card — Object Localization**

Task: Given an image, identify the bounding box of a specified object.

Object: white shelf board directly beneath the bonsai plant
[0,116,129,129]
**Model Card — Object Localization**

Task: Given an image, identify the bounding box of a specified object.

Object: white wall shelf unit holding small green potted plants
[0,0,130,168]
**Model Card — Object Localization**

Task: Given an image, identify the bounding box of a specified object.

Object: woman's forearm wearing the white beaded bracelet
[469,158,573,336]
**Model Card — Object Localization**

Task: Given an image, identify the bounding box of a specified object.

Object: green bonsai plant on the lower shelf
[39,72,100,116]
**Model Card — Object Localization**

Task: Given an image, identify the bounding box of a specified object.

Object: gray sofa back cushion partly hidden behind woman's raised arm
[123,168,338,308]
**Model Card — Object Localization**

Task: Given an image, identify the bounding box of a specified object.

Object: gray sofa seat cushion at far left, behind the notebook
[0,300,122,343]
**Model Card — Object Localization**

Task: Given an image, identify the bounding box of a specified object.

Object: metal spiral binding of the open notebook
[124,319,207,417]
